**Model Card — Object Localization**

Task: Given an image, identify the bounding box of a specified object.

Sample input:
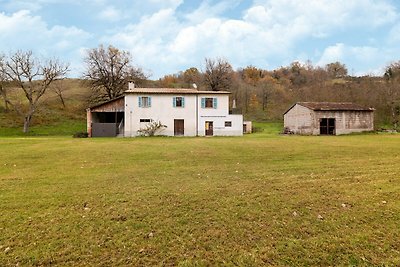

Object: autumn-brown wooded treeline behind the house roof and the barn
[155,59,400,128]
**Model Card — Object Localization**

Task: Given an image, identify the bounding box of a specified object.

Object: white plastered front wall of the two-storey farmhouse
[125,93,243,137]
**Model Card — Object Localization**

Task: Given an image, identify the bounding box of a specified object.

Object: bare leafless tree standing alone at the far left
[0,51,68,133]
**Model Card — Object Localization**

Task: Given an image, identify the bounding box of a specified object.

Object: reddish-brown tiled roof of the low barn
[284,102,374,114]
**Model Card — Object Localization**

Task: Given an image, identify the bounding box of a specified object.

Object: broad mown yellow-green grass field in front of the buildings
[0,124,400,266]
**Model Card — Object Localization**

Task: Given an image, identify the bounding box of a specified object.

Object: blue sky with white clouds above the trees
[0,0,400,79]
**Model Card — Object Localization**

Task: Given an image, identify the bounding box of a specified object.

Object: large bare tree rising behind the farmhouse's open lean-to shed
[84,45,147,102]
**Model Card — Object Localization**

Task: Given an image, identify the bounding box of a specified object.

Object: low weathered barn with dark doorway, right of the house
[284,102,374,135]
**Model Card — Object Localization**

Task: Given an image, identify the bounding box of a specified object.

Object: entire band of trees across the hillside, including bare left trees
[0,45,400,132]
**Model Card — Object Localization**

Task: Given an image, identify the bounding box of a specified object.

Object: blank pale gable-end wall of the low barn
[284,104,319,134]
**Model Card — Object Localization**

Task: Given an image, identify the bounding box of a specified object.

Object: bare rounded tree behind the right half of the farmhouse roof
[204,58,233,91]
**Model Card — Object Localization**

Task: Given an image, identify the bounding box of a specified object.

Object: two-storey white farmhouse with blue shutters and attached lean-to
[87,83,243,137]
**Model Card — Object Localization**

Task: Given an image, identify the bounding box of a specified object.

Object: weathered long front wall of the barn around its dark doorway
[313,111,374,135]
